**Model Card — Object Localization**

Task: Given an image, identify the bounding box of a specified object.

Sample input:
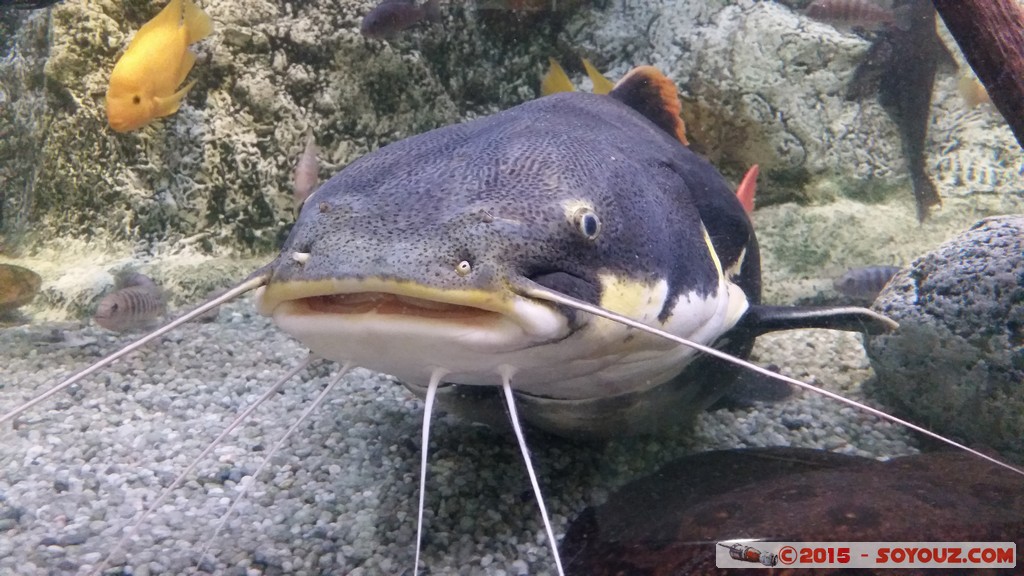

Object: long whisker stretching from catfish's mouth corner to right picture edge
[518,283,1024,476]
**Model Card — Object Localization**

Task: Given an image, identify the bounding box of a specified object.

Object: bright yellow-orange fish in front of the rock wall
[106,0,213,132]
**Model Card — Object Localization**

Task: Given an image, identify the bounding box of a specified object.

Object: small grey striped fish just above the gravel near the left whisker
[92,273,167,332]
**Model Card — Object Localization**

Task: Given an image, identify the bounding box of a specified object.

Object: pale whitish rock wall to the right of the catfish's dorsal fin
[570,0,1024,207]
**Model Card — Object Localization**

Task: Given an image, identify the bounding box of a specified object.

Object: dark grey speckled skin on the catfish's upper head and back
[271,93,760,319]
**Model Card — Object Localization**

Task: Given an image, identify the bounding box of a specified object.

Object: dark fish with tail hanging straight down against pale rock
[847,0,955,221]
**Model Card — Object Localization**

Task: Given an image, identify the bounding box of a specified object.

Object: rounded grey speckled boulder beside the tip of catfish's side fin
[866,215,1024,457]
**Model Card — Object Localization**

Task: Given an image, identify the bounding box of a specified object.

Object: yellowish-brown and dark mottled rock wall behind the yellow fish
[8,0,581,252]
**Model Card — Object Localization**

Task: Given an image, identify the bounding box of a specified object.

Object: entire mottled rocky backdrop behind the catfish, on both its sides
[0,0,1024,316]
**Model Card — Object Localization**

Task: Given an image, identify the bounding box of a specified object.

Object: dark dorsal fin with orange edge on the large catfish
[610,66,690,145]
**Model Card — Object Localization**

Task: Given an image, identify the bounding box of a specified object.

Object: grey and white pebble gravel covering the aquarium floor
[0,300,914,575]
